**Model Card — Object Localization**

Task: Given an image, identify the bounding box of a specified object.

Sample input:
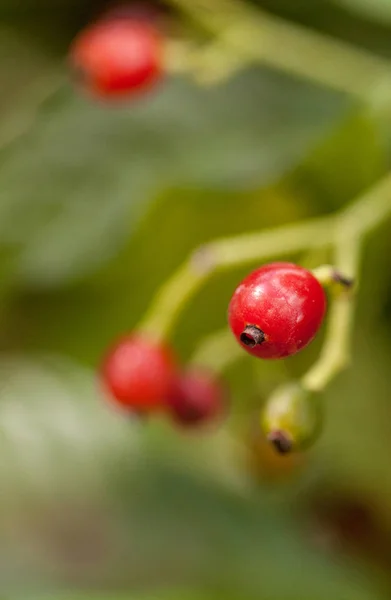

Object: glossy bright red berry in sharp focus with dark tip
[228,263,326,358]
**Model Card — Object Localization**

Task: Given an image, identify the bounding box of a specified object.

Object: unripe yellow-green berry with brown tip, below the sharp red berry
[261,382,321,454]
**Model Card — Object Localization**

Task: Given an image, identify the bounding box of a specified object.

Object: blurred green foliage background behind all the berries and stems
[0,0,391,600]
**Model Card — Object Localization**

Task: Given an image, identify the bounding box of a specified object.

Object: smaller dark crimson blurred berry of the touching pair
[167,369,226,426]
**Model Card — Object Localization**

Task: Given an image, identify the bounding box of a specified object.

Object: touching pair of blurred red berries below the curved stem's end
[102,334,225,427]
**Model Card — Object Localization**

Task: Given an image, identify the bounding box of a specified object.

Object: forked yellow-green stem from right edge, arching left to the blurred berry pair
[139,173,391,352]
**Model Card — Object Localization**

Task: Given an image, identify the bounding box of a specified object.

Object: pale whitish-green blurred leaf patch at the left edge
[0,357,139,505]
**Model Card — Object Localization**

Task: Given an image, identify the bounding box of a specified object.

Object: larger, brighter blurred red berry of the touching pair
[102,334,176,412]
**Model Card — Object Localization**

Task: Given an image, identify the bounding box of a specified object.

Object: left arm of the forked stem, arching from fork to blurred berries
[139,217,334,339]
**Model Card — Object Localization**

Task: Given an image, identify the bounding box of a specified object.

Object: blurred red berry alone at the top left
[70,19,162,98]
